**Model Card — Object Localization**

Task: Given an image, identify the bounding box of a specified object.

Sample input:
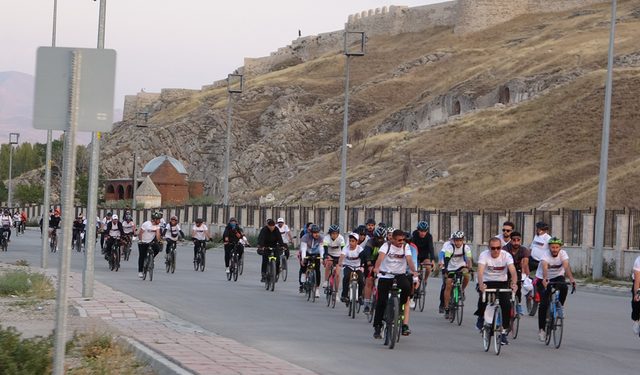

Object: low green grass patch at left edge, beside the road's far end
[0,270,56,299]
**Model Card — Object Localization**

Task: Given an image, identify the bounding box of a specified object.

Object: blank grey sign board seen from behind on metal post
[33,47,116,132]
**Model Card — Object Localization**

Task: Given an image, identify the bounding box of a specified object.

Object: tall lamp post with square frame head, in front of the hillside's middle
[338,30,366,233]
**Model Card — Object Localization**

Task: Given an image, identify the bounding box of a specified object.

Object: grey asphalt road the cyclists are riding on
[0,229,640,375]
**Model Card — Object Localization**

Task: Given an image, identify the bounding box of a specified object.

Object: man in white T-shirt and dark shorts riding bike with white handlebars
[474,237,518,345]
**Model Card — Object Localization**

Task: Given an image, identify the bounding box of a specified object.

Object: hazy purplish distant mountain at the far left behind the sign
[0,72,122,144]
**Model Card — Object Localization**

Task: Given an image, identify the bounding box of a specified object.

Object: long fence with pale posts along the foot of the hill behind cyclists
[8,204,640,249]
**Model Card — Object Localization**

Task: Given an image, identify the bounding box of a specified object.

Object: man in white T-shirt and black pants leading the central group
[373,228,418,339]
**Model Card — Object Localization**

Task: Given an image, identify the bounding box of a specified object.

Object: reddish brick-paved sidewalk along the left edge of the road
[31,268,313,375]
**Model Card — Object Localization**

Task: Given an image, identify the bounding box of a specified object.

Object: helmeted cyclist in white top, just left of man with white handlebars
[444,231,472,319]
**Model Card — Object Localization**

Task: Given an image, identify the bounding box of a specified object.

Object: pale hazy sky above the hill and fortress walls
[0,0,442,108]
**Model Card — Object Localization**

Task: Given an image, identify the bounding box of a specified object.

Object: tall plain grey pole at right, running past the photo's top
[592,0,617,280]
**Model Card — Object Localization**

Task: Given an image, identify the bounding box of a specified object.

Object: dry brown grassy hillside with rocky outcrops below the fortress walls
[101,0,640,209]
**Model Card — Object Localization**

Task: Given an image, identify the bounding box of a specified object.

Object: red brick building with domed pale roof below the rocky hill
[104,155,203,205]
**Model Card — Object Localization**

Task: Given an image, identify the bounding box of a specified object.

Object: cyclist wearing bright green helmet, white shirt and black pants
[536,237,576,341]
